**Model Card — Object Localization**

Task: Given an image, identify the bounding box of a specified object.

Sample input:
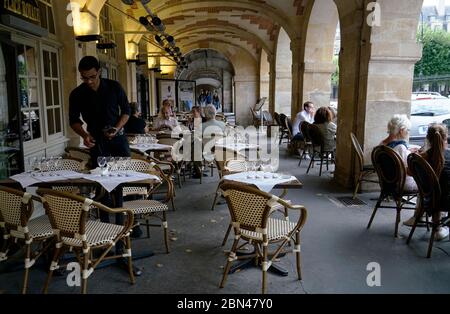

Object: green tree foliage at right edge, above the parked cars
[414,27,450,77]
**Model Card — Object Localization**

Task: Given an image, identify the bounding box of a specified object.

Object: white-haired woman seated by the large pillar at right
[380,114,417,191]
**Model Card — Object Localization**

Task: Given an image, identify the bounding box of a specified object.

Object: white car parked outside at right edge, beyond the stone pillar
[410,95,450,142]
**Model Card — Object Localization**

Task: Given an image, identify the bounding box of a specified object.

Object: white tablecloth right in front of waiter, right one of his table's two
[82,171,161,192]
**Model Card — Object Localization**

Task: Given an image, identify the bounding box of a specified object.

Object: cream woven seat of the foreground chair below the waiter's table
[62,220,123,247]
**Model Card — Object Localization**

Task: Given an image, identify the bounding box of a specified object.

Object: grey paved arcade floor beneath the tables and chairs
[0,150,450,294]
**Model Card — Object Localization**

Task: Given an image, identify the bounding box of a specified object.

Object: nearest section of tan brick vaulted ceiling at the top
[107,0,311,60]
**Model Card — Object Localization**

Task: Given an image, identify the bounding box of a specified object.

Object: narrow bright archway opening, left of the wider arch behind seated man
[275,28,292,115]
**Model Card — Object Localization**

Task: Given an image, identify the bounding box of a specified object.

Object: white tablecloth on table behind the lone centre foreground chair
[223,171,297,192]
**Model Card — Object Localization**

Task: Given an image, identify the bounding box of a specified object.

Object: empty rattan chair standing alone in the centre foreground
[220,182,307,293]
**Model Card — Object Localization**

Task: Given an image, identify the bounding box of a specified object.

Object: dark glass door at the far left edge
[0,37,24,179]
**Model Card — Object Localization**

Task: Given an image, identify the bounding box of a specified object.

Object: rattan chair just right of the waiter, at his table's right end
[123,159,174,253]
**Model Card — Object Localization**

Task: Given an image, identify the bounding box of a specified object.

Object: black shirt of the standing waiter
[69,78,130,138]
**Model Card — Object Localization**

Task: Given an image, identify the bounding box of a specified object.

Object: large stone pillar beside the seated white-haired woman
[334,0,423,186]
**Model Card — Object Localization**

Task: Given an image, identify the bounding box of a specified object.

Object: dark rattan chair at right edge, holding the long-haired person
[406,154,448,258]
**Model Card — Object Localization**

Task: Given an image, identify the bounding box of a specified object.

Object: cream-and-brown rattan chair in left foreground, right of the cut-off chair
[37,189,135,294]
